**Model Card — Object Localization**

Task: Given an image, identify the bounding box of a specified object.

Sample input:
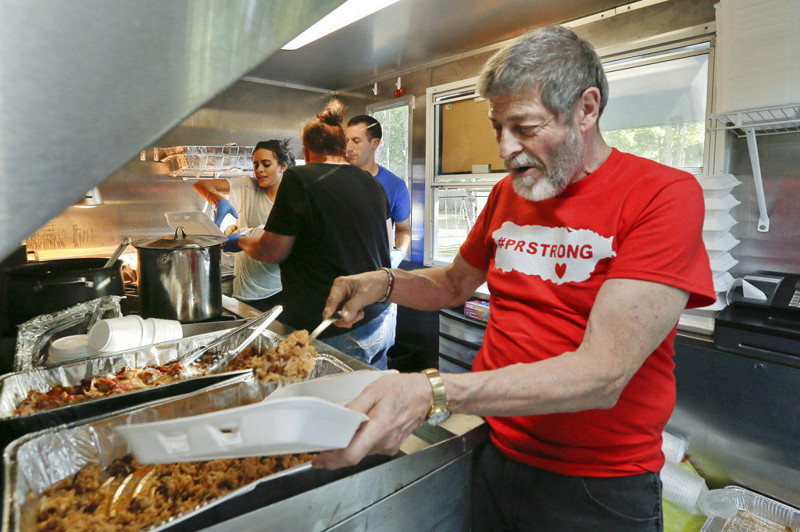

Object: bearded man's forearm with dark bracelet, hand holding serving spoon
[322,255,486,327]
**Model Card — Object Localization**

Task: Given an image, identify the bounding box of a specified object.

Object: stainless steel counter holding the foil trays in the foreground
[222,298,489,532]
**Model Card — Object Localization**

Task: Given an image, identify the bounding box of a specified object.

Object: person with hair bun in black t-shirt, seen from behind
[231,100,395,369]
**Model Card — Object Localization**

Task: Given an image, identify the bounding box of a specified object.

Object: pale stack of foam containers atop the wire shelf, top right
[715,0,800,113]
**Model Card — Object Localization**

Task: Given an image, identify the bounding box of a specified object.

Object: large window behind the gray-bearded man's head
[424,29,712,266]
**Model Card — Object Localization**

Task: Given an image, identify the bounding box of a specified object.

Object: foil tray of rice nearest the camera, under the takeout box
[2,354,351,532]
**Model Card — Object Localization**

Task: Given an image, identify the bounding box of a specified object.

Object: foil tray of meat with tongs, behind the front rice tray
[0,318,283,446]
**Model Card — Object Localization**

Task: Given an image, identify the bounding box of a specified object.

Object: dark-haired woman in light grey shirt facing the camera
[192,139,294,310]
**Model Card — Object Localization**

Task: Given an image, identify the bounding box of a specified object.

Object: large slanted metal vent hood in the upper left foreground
[0,0,343,259]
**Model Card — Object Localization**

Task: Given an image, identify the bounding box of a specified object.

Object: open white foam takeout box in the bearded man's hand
[114,370,397,464]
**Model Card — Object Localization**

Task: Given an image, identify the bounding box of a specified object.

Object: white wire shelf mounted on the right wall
[709,104,800,137]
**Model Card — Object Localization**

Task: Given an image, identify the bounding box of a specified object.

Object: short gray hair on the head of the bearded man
[478,26,608,120]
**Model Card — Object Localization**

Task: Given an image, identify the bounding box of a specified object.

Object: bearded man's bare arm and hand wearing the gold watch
[314,279,689,469]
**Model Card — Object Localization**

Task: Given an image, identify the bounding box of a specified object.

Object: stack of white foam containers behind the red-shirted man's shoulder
[678,174,741,334]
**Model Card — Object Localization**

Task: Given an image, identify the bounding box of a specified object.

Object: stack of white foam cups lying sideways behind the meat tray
[88,314,183,353]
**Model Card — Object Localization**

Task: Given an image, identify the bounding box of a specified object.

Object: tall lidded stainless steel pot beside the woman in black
[133,227,225,323]
